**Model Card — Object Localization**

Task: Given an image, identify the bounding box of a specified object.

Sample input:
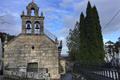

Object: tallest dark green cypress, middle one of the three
[83,2,95,63]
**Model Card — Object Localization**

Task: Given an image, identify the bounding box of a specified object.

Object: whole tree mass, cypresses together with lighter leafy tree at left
[67,2,105,63]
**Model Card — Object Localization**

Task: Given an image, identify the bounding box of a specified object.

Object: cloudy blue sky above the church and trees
[0,0,120,54]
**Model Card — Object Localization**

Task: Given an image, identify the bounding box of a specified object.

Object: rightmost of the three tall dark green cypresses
[92,6,105,62]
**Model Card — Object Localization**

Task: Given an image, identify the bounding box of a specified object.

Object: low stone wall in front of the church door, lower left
[4,71,50,80]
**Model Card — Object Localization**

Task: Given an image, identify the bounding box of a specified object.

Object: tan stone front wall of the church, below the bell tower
[4,35,60,79]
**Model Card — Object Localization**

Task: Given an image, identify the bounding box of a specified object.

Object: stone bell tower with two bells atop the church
[21,1,44,35]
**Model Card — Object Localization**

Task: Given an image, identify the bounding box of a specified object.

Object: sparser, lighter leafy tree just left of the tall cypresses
[67,22,80,60]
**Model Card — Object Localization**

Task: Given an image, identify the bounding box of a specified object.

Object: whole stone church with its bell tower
[4,2,62,80]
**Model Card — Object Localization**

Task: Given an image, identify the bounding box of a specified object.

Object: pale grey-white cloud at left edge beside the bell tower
[0,14,20,35]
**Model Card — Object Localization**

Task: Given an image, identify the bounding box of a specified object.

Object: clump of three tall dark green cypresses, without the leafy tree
[79,2,104,64]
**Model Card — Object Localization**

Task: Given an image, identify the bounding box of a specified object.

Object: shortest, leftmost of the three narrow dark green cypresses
[78,13,88,62]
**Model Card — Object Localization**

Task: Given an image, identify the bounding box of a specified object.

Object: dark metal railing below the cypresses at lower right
[73,63,120,80]
